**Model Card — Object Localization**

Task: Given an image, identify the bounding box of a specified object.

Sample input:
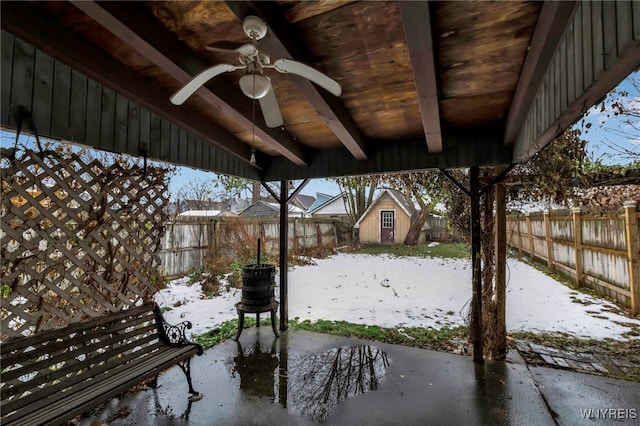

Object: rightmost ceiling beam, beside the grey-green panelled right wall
[504,0,578,145]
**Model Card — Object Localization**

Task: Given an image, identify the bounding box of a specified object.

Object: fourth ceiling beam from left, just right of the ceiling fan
[398,1,442,154]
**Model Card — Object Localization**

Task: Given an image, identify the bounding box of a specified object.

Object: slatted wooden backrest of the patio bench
[0,303,166,413]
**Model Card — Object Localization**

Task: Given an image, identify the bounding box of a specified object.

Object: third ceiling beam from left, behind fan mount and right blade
[226,1,367,160]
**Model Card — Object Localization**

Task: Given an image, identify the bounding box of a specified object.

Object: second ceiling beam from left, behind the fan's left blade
[71,0,307,165]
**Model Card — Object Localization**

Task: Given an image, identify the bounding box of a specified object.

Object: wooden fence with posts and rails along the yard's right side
[507,201,640,315]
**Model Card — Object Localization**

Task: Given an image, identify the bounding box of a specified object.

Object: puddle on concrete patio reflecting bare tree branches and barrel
[232,340,389,422]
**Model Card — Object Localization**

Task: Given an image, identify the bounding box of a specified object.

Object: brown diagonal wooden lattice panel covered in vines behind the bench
[0,149,168,339]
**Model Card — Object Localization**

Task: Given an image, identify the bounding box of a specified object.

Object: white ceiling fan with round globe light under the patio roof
[170,15,342,127]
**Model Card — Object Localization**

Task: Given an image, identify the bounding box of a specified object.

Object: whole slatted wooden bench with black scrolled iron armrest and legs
[0,303,202,425]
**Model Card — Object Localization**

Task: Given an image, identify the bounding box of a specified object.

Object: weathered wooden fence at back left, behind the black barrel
[160,217,351,279]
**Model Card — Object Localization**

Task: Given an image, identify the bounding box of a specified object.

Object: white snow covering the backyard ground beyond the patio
[156,253,640,339]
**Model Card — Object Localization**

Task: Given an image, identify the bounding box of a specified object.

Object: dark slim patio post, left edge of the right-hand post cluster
[469,166,484,362]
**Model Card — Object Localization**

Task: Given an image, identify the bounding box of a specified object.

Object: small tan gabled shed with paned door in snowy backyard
[354,189,424,243]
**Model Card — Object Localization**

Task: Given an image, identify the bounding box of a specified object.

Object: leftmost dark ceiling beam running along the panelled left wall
[2,2,251,163]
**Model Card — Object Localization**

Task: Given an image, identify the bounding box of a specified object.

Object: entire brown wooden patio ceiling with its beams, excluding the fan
[2,0,636,179]
